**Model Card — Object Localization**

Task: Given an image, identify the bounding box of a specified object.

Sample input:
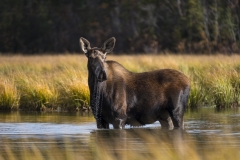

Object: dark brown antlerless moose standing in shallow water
[80,37,190,129]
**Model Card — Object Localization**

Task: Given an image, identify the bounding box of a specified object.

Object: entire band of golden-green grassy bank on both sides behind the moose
[0,54,240,111]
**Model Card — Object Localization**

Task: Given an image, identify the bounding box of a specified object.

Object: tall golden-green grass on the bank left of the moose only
[0,55,89,111]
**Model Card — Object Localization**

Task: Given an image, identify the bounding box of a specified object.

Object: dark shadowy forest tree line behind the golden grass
[0,0,240,54]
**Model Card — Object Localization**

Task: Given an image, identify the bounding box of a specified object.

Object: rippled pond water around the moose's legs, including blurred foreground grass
[0,108,240,160]
